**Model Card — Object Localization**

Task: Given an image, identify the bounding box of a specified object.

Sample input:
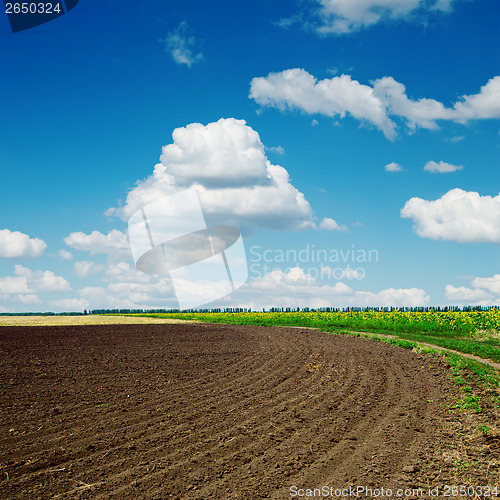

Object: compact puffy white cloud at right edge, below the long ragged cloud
[401,188,500,243]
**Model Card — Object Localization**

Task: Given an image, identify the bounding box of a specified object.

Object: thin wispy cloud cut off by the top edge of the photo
[308,0,453,35]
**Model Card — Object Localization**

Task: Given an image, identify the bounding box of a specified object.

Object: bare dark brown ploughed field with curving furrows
[0,324,500,500]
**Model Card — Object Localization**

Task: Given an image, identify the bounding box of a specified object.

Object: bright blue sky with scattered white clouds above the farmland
[0,0,500,312]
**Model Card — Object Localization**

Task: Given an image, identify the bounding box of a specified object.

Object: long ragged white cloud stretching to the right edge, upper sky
[250,68,500,139]
